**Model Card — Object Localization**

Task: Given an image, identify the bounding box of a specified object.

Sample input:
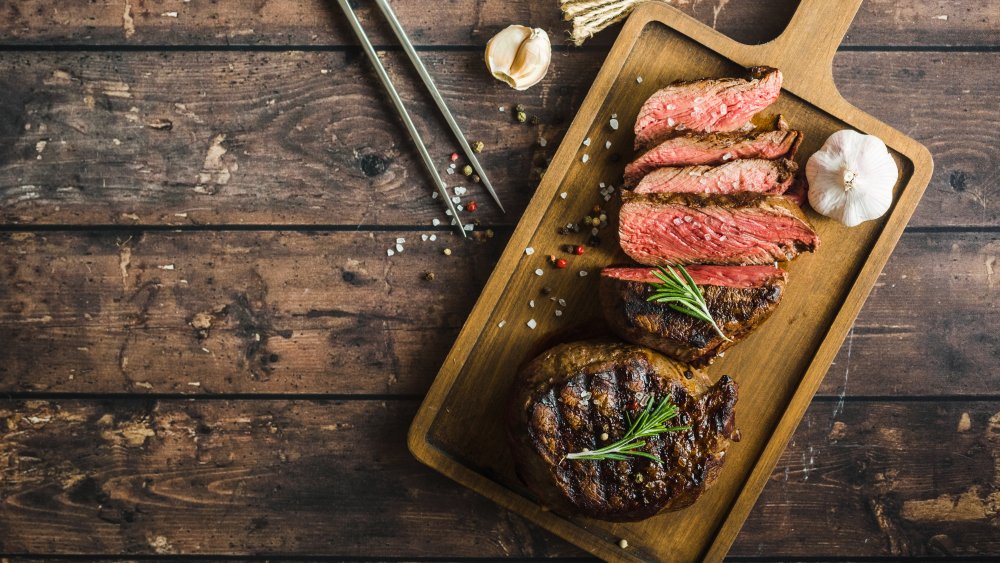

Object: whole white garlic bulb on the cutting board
[806,129,899,227]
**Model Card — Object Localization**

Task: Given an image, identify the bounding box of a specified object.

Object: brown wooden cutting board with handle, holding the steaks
[409,0,933,561]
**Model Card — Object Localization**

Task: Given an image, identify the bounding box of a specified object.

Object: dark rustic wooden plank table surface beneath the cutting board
[0,0,1000,561]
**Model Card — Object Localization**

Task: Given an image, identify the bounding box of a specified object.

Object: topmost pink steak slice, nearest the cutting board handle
[635,67,781,148]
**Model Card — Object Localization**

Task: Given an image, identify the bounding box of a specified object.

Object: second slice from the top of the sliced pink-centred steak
[625,130,802,188]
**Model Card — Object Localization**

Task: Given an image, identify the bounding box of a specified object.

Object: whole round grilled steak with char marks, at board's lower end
[507,340,739,522]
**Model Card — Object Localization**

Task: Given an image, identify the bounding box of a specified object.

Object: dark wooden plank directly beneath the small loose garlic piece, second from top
[0,51,1000,226]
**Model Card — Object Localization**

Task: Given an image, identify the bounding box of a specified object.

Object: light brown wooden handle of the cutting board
[760,0,862,90]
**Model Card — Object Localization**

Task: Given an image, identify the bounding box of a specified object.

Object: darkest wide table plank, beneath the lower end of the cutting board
[0,400,1000,559]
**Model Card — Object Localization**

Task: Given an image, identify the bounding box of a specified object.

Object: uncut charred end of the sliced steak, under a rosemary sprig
[601,266,787,366]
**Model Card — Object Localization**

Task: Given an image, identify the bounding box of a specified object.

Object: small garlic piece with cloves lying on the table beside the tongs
[486,25,552,90]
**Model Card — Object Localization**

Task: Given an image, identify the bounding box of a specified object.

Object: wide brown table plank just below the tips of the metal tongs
[0,232,1000,396]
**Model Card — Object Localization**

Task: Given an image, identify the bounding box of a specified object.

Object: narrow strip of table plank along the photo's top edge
[0,0,1000,46]
